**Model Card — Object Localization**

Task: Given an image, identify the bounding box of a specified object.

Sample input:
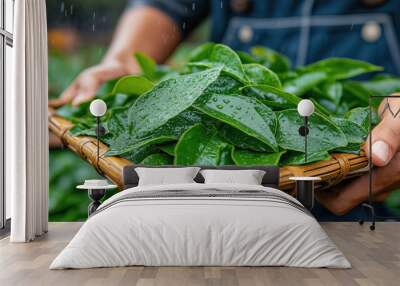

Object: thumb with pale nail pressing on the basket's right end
[365,103,400,166]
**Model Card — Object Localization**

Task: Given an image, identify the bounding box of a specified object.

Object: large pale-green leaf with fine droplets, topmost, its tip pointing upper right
[129,68,221,136]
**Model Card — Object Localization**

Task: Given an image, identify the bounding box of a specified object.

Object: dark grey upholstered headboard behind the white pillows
[123,165,280,189]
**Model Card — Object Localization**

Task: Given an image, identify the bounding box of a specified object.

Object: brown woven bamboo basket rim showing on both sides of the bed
[48,108,368,192]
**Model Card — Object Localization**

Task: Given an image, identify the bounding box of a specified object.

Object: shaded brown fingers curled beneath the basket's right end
[316,153,400,215]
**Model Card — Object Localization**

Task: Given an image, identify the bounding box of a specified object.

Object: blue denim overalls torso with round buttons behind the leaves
[211,0,400,75]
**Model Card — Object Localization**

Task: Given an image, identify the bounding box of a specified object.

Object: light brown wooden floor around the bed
[0,222,400,286]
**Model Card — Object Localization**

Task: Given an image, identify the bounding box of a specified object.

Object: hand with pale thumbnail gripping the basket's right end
[317,94,400,215]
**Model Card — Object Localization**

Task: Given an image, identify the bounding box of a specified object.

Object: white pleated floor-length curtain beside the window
[5,0,48,242]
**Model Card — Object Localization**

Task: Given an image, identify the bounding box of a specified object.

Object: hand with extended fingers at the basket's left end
[49,56,139,107]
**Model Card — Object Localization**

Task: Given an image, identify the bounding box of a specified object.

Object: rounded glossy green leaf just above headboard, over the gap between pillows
[174,124,226,166]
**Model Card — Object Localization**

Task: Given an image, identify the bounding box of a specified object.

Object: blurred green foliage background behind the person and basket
[47,0,400,221]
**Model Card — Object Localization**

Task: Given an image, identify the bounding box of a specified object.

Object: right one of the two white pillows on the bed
[200,169,265,185]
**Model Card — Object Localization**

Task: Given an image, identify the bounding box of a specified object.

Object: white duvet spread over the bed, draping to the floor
[50,184,350,269]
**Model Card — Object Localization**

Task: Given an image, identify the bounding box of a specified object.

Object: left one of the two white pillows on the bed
[135,167,200,186]
